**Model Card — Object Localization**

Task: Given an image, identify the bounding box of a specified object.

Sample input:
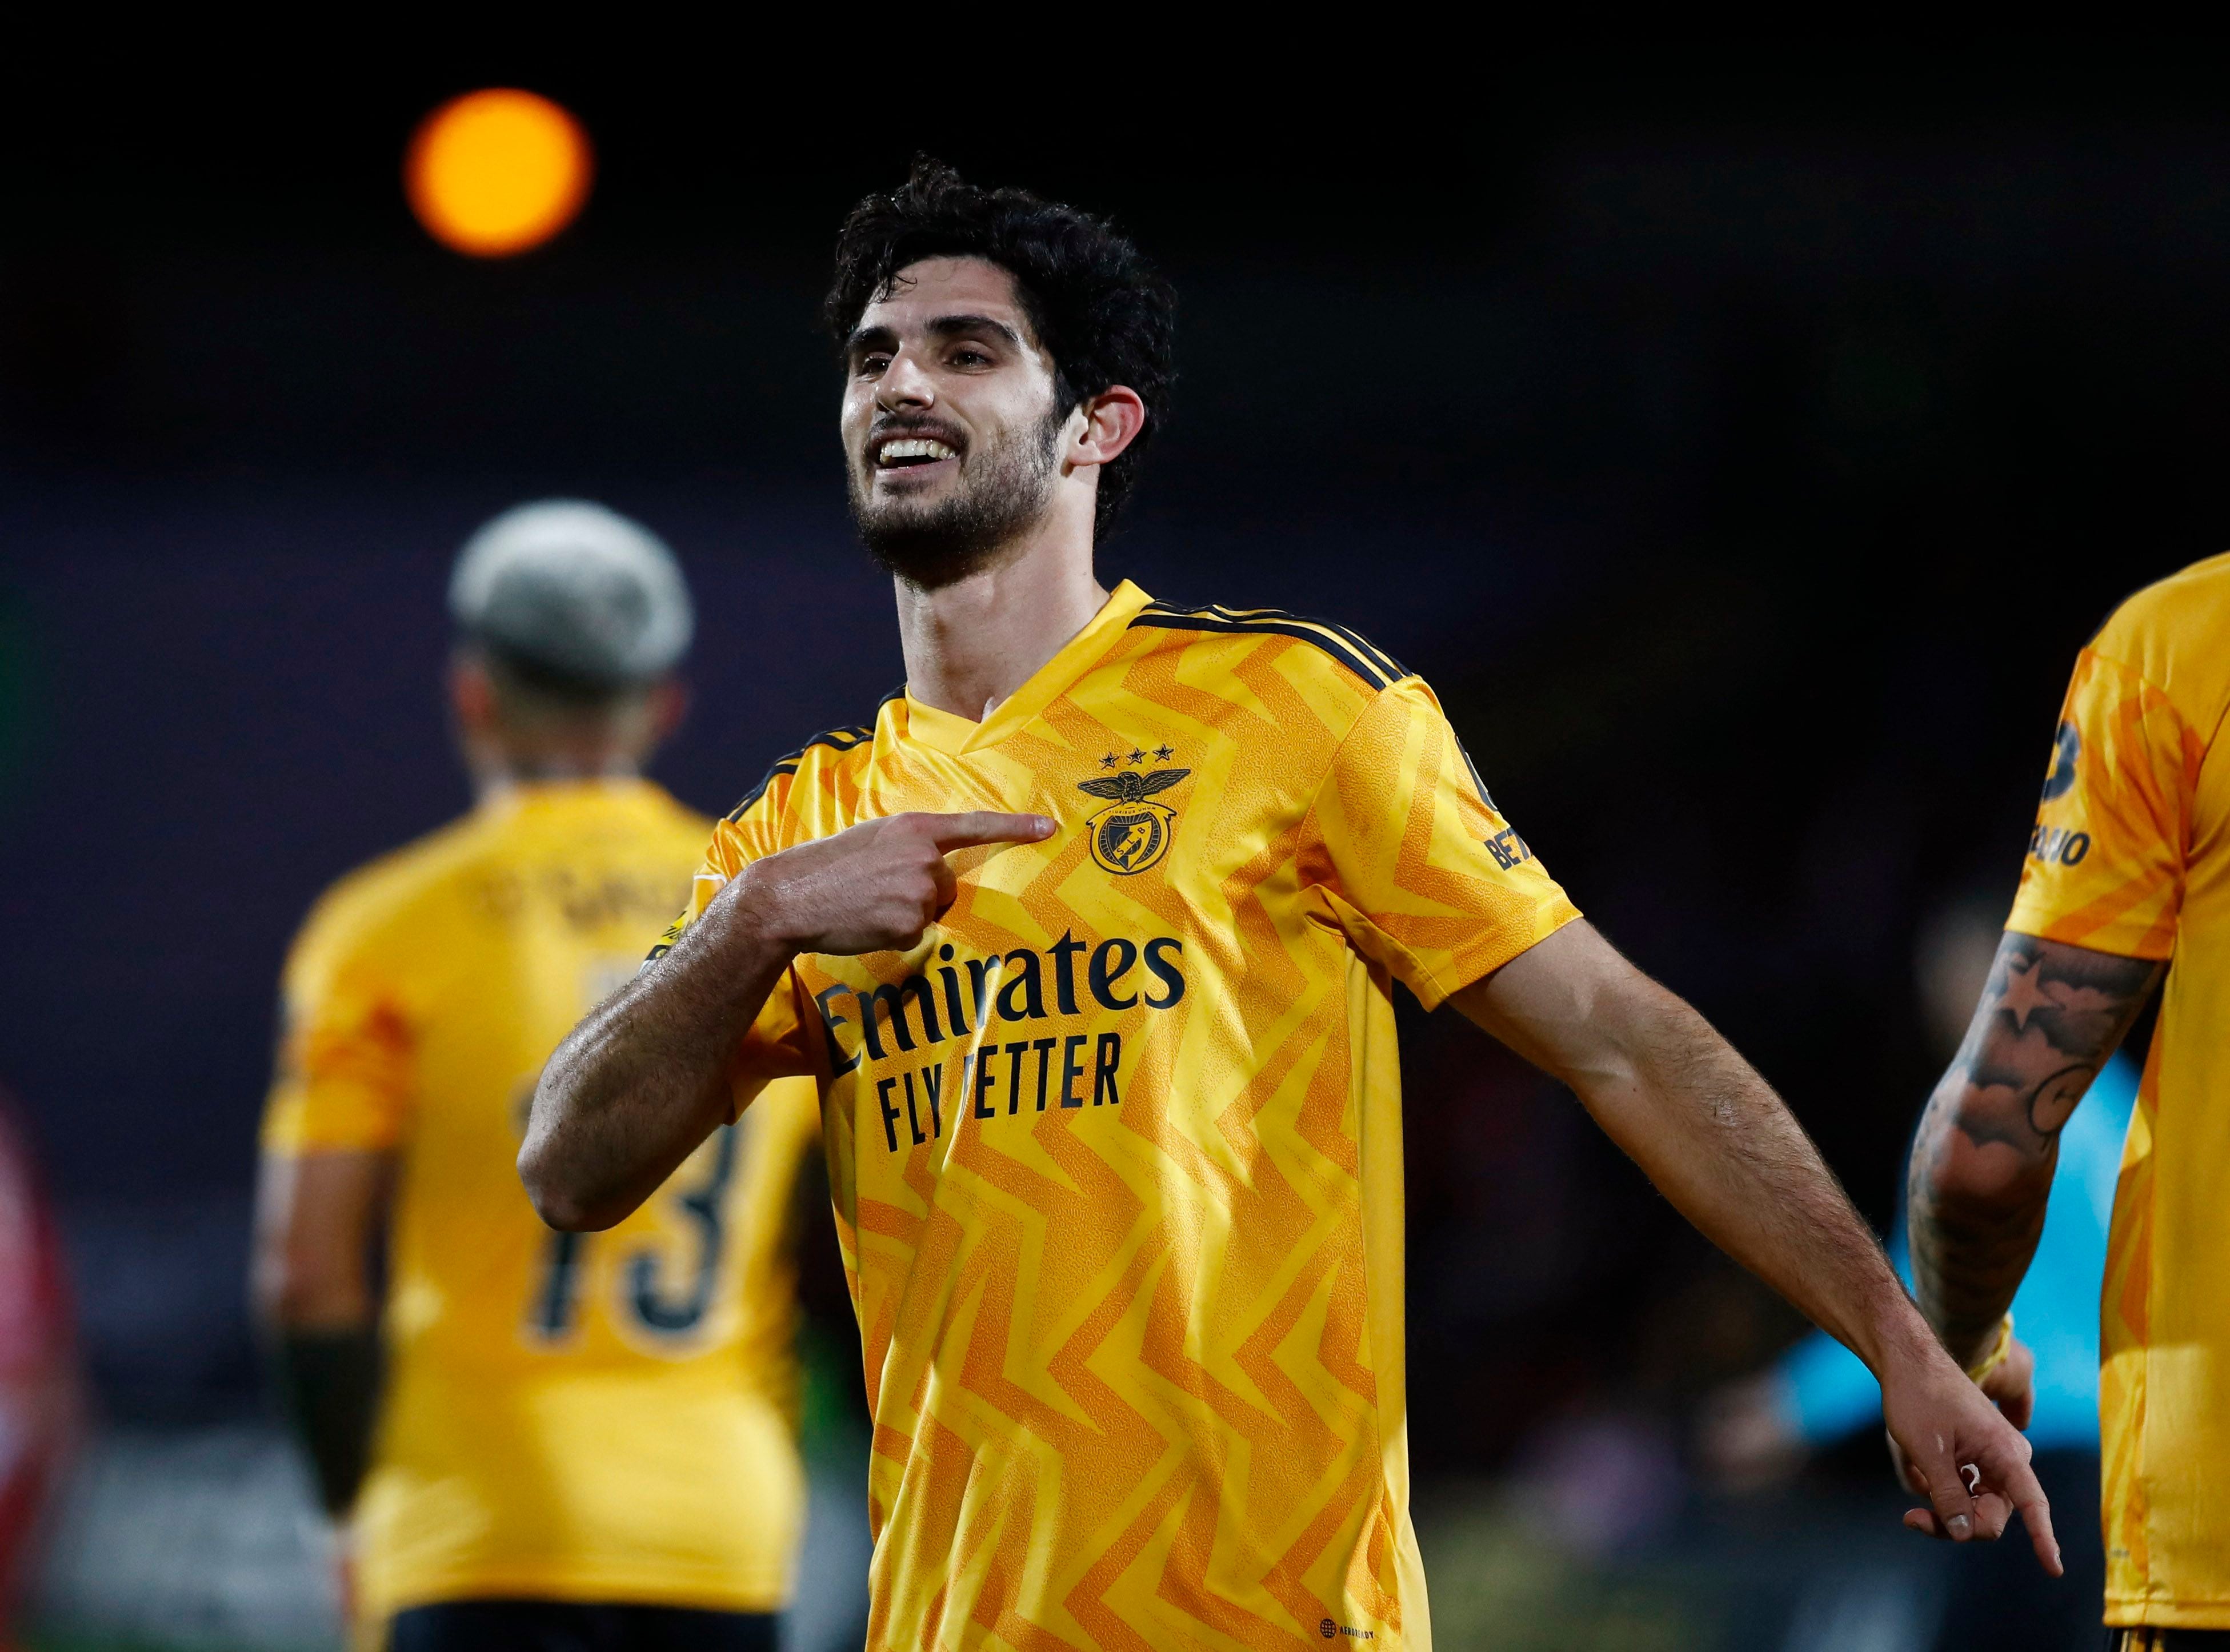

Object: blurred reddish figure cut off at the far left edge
[0,1092,78,1647]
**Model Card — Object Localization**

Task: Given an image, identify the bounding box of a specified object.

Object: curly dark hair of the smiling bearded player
[820,154,1178,533]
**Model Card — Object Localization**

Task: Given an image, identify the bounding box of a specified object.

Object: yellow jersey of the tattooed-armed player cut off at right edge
[2009,555,2230,1630]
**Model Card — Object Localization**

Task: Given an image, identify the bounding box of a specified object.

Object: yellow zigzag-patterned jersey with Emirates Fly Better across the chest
[651,584,1576,1652]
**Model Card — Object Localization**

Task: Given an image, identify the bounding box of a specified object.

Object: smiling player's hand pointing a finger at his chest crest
[720,812,1052,956]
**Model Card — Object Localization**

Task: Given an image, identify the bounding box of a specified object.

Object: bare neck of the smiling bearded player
[896,517,1108,723]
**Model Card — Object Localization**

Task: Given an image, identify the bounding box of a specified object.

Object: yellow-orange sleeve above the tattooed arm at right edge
[2007,642,2205,959]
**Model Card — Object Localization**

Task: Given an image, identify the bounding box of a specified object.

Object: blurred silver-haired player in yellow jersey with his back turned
[257,502,818,1652]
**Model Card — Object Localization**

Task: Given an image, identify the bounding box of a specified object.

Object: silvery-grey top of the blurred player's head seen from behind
[449,499,696,689]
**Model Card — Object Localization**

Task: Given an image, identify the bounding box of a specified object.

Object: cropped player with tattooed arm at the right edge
[1909,555,2230,1647]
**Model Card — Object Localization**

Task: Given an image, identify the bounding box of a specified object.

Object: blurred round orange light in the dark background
[403,87,595,259]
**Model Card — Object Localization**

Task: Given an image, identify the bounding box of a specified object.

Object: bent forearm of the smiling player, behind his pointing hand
[519,889,792,1228]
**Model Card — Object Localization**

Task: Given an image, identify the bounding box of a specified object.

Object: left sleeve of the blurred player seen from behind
[263,896,415,1155]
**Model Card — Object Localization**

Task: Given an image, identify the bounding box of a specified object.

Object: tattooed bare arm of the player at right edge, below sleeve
[1907,929,2165,1365]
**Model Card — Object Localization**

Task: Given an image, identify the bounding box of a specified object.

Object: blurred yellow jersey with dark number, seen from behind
[263,780,818,1630]
